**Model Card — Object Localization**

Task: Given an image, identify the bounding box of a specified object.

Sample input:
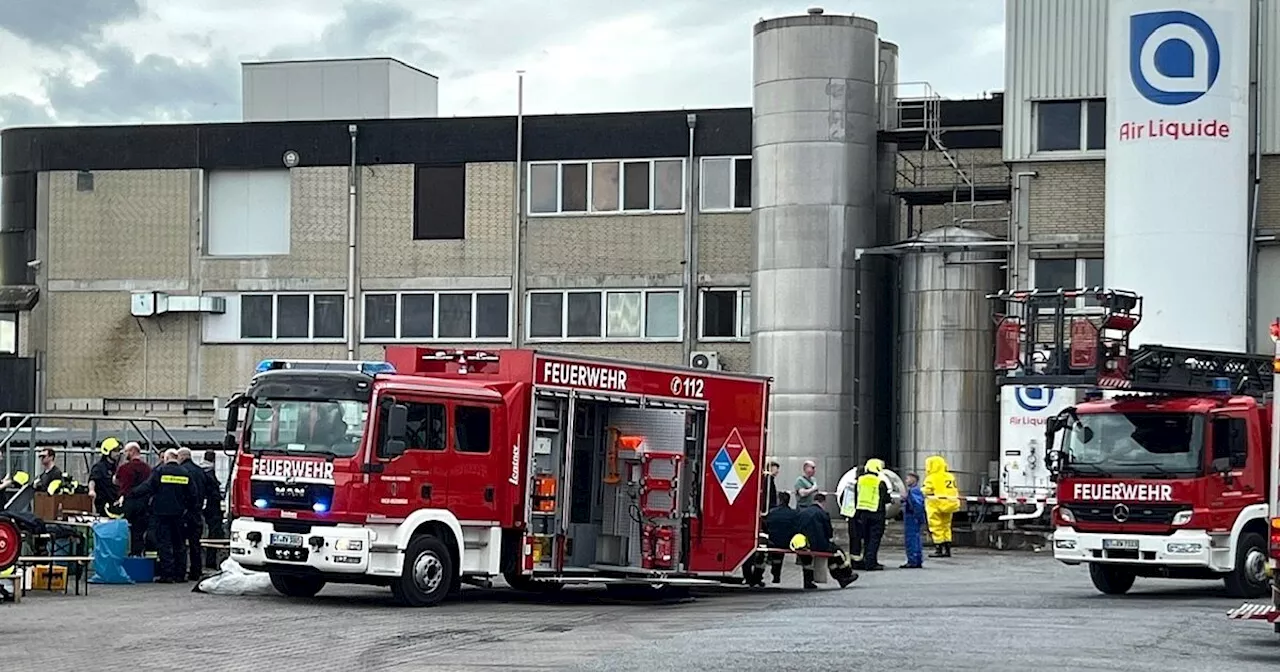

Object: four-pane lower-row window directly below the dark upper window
[364,292,511,342]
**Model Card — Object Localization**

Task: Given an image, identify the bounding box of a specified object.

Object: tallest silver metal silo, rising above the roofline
[751,9,879,489]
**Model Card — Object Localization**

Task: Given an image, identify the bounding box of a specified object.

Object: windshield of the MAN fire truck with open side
[244,398,369,457]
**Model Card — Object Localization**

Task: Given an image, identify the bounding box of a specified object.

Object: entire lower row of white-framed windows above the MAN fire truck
[205,289,751,343]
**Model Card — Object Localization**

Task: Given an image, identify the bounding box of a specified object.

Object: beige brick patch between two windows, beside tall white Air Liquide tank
[1025,160,1106,241]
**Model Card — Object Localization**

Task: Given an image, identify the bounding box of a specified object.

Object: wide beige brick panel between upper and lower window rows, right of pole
[525,215,685,276]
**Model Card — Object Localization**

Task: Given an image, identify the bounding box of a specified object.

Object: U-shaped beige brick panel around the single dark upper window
[360,163,515,278]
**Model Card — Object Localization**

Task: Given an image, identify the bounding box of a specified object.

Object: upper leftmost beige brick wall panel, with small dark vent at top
[45,170,191,280]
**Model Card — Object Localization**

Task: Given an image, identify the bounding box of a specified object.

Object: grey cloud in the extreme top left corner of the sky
[0,0,142,47]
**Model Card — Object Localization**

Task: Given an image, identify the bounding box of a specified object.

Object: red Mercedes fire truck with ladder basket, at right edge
[992,288,1280,622]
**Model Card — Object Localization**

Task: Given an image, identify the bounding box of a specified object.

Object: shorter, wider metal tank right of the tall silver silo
[896,227,1004,495]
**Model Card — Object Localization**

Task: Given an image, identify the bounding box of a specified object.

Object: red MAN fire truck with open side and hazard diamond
[227,347,771,607]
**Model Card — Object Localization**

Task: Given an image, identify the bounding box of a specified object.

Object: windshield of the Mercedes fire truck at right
[1064,412,1204,479]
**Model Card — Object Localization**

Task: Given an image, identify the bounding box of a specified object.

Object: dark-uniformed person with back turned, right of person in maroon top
[134,451,200,584]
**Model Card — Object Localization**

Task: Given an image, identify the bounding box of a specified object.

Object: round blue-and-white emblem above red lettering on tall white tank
[1129,10,1222,105]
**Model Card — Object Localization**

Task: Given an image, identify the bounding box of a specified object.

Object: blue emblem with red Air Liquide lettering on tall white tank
[1120,10,1231,141]
